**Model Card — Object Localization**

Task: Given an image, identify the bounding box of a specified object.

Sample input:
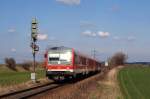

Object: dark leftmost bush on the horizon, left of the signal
[5,58,17,71]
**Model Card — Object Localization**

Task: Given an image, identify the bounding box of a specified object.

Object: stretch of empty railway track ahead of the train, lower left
[0,82,64,99]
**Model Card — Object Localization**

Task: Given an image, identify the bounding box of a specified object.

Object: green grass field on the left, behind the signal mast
[0,66,45,87]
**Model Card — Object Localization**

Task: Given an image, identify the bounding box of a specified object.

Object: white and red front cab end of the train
[45,49,75,80]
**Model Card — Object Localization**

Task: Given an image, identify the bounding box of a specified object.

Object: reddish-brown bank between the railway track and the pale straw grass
[34,72,105,99]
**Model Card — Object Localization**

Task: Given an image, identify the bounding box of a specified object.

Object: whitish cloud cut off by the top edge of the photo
[56,0,81,5]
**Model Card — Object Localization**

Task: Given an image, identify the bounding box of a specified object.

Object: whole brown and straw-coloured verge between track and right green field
[40,67,123,99]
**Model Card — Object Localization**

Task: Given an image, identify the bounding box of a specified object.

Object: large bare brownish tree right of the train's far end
[109,52,127,67]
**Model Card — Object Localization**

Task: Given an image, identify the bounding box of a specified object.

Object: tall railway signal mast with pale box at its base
[30,18,39,82]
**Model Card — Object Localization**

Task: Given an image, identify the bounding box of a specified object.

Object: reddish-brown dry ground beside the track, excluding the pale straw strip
[38,73,106,99]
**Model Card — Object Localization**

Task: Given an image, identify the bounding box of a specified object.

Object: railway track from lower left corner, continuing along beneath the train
[0,71,105,99]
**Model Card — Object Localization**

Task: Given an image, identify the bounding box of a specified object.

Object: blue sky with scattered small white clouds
[0,0,150,63]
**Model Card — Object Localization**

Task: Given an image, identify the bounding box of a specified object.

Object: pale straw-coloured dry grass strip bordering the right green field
[96,66,123,99]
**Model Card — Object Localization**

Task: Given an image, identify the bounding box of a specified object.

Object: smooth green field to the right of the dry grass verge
[118,67,150,99]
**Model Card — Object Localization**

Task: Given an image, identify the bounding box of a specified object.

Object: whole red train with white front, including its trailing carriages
[45,47,101,80]
